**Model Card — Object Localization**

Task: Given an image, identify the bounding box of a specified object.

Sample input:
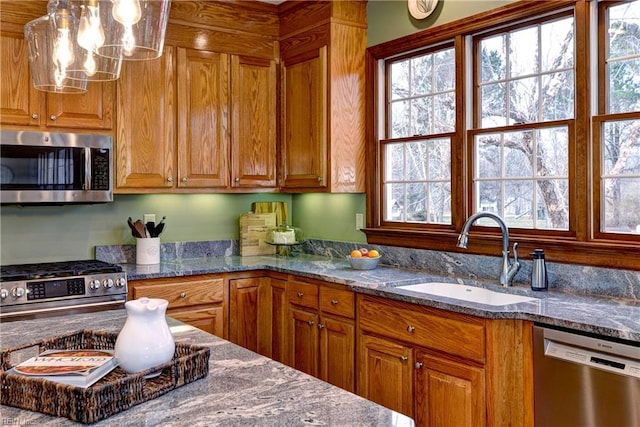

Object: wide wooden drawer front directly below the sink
[358,297,485,362]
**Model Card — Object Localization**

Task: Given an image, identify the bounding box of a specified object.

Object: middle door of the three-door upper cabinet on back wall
[177,48,230,188]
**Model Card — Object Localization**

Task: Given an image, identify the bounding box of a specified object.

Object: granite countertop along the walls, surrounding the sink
[122,254,640,342]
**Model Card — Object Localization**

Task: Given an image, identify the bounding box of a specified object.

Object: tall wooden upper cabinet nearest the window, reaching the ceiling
[280,1,366,192]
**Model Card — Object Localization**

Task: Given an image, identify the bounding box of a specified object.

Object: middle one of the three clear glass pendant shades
[71,0,122,82]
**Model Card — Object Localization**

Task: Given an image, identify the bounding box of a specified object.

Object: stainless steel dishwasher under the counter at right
[533,325,640,427]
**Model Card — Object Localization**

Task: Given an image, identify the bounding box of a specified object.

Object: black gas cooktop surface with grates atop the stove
[0,259,122,282]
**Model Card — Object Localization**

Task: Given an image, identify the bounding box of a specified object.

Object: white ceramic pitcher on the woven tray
[114,297,176,376]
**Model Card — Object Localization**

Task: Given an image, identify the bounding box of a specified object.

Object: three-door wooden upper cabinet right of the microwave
[116,46,276,193]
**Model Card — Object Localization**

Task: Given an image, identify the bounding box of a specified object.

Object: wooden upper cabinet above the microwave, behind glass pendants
[0,31,114,132]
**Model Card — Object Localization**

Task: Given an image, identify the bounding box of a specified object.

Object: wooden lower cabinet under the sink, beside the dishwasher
[357,295,533,427]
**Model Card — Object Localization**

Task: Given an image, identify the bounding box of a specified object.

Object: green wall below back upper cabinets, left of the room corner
[0,194,293,265]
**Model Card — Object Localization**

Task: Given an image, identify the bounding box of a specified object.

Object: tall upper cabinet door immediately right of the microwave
[115,46,176,192]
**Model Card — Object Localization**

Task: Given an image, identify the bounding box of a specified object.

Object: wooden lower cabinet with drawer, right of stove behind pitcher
[129,275,227,338]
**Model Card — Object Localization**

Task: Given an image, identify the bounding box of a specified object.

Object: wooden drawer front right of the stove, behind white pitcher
[133,279,224,308]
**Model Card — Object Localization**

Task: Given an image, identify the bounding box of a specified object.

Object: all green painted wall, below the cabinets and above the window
[0,0,509,265]
